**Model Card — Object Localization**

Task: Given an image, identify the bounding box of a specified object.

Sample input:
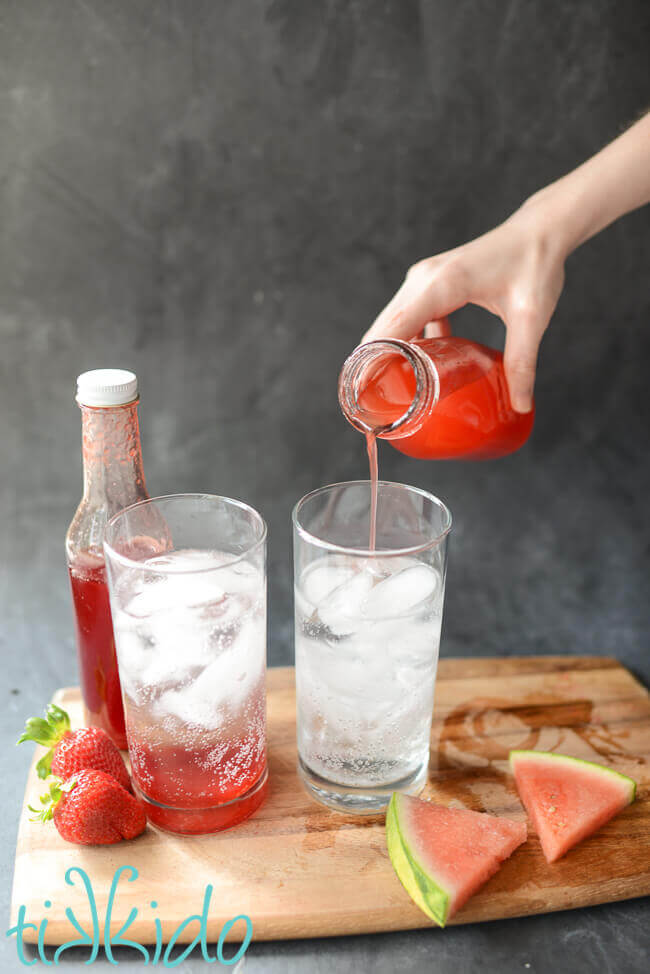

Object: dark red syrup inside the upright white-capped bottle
[70,553,126,749]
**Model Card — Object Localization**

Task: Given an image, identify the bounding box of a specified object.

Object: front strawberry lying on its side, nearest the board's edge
[28,769,147,845]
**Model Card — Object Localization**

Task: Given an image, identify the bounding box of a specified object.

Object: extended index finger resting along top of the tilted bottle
[362,261,468,342]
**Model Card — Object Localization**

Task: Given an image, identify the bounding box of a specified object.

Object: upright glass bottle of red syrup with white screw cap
[65,369,149,748]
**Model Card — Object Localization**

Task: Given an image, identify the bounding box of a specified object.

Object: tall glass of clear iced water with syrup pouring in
[293,481,451,812]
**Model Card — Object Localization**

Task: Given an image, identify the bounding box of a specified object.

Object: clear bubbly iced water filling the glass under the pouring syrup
[296,554,443,787]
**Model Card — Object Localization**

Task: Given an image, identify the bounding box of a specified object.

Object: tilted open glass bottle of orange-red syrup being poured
[339,335,535,460]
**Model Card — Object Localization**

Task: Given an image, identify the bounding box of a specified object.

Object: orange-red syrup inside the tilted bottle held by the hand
[358,336,535,460]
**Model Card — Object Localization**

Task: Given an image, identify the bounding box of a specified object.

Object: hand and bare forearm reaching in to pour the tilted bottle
[363,112,650,413]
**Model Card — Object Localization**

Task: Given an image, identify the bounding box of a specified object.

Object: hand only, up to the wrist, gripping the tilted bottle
[363,199,565,413]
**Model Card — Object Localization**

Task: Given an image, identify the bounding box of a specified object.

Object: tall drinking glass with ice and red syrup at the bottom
[104,494,267,833]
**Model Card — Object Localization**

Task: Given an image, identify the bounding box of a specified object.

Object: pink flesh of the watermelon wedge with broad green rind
[397,794,527,919]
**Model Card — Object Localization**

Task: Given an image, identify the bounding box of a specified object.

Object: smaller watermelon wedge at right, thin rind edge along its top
[510,751,636,862]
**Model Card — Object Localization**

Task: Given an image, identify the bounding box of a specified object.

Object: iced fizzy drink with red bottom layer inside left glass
[113,550,266,807]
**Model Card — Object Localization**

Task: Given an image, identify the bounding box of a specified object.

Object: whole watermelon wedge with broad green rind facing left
[386,792,526,927]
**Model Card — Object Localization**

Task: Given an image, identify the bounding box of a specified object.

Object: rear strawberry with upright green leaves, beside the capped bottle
[17,703,131,791]
